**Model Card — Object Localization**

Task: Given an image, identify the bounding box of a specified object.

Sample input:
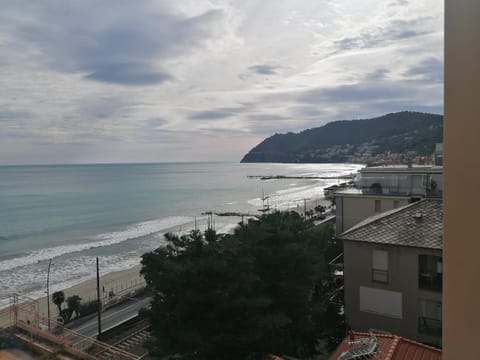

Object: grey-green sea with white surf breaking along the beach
[0,162,362,298]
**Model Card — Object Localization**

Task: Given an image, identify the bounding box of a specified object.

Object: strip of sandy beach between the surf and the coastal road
[38,265,145,318]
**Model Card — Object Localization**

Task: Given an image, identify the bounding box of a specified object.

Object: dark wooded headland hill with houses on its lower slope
[242,111,443,162]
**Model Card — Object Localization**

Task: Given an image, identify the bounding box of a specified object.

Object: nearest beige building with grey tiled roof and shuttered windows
[339,199,443,346]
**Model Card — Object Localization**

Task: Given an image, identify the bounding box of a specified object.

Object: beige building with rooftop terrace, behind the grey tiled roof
[334,165,443,234]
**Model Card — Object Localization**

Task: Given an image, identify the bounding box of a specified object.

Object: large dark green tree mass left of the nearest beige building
[142,212,344,360]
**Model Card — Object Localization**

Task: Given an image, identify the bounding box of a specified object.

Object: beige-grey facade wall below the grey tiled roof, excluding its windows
[344,241,442,345]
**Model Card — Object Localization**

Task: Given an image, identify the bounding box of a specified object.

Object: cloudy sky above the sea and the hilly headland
[0,0,443,164]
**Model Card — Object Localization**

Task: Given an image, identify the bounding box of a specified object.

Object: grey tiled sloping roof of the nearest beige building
[338,199,443,249]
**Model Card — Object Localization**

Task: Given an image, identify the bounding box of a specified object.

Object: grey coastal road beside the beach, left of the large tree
[69,297,152,337]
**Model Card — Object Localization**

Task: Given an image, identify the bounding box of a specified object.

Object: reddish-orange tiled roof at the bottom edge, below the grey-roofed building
[330,331,442,360]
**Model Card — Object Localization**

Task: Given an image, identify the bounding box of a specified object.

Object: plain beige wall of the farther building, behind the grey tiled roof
[335,194,410,235]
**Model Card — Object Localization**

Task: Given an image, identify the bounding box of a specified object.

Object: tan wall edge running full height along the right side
[443,0,480,360]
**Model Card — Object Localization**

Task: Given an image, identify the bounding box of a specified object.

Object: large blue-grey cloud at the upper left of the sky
[6,0,223,86]
